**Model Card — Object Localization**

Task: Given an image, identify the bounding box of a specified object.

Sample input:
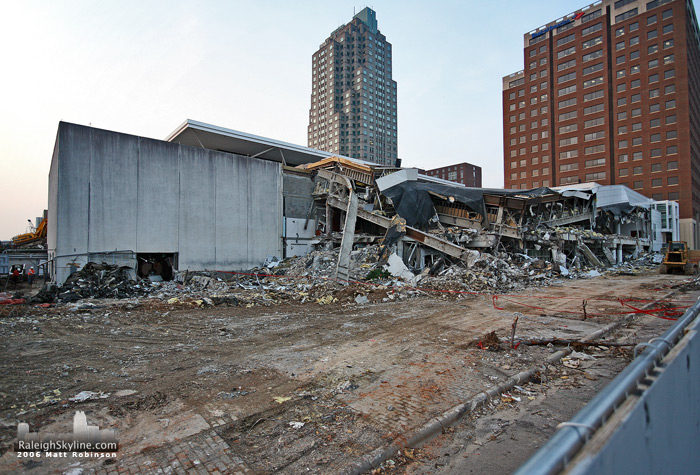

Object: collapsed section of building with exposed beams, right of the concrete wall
[301,161,661,278]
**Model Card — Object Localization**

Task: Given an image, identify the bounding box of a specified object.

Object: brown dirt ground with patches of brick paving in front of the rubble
[0,273,699,473]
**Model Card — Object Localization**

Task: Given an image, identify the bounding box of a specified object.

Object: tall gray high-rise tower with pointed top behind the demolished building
[308,8,400,166]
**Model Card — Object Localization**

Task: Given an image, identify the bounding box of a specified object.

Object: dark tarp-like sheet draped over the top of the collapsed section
[382,181,557,227]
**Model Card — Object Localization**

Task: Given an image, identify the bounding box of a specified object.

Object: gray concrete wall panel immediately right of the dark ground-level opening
[178,147,216,270]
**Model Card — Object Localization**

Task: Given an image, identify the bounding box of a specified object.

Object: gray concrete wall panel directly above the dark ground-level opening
[136,138,180,252]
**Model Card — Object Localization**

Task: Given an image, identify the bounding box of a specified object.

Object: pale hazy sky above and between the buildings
[0,0,696,240]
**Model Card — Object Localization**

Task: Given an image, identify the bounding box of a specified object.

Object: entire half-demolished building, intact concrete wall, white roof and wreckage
[47,120,660,283]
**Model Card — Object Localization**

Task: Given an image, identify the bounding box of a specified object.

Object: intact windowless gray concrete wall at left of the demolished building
[47,122,282,282]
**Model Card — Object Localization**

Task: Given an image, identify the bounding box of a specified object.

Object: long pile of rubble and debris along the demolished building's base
[24,244,661,307]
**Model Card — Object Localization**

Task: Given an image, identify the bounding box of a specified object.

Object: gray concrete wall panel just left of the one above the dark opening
[88,129,141,252]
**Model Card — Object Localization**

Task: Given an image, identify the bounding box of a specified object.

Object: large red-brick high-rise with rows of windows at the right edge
[503,0,700,246]
